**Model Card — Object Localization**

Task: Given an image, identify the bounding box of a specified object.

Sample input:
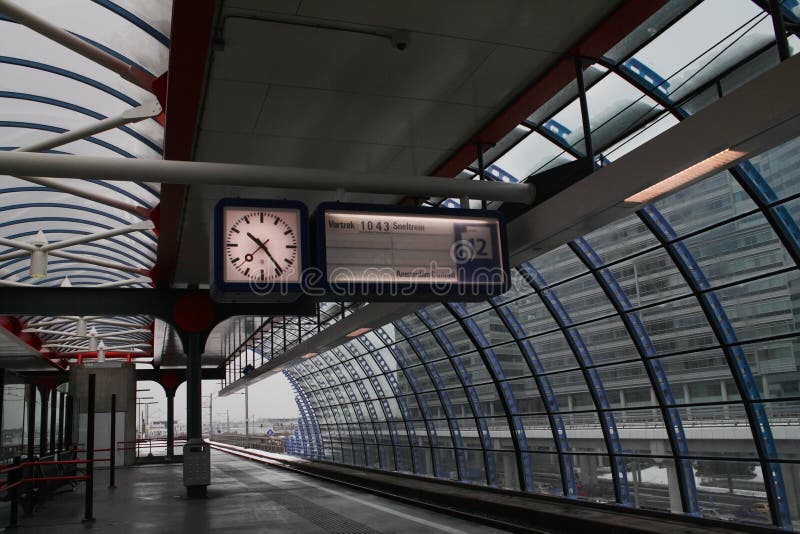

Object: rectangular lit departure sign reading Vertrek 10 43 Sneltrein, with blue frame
[316,202,509,300]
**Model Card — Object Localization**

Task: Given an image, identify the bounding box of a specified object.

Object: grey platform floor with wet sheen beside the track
[0,451,500,534]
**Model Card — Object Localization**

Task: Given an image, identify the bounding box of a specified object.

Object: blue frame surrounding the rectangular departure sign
[313,202,511,302]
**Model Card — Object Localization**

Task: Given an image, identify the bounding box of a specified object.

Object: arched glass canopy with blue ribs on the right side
[285,0,800,529]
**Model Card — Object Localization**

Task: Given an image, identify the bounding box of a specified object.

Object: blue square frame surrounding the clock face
[210,197,311,302]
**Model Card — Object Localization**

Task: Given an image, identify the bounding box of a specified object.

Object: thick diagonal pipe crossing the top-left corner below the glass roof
[0,0,153,91]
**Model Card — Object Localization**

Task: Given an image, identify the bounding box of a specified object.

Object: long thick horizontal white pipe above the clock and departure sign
[0,152,535,204]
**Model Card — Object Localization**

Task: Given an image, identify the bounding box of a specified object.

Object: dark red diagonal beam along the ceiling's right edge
[433,0,667,178]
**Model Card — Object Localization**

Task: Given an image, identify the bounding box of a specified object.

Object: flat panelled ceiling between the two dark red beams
[175,0,620,283]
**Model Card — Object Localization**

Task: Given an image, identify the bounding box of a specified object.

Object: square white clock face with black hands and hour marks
[222,207,302,283]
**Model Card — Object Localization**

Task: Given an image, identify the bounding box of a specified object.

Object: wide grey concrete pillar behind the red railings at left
[69,360,136,465]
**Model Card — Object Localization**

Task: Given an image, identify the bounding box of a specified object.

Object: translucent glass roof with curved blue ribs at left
[0,0,172,360]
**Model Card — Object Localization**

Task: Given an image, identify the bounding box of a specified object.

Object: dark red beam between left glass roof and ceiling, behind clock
[151,0,216,287]
